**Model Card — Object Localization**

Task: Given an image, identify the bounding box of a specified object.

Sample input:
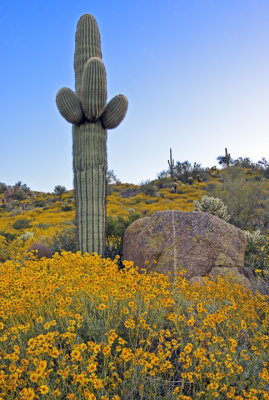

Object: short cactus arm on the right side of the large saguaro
[101,94,128,129]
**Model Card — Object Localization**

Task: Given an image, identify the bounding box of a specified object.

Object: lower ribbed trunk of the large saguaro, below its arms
[73,121,107,254]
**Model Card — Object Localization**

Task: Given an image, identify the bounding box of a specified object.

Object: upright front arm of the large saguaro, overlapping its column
[80,57,107,121]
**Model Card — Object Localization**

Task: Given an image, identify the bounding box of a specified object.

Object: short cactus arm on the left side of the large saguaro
[56,88,84,125]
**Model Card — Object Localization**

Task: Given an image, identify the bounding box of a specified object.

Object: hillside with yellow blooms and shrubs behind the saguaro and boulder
[0,162,269,268]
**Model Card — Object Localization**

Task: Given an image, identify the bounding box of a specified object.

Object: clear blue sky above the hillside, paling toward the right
[0,0,269,192]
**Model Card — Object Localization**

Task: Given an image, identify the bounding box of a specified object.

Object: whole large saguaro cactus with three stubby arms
[56,14,128,255]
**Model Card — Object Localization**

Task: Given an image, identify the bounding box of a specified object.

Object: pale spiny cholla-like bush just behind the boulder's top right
[193,196,230,222]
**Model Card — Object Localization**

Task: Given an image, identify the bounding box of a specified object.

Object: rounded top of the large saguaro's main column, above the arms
[74,14,102,95]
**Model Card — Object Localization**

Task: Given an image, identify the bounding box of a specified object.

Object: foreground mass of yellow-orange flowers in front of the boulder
[0,253,269,400]
